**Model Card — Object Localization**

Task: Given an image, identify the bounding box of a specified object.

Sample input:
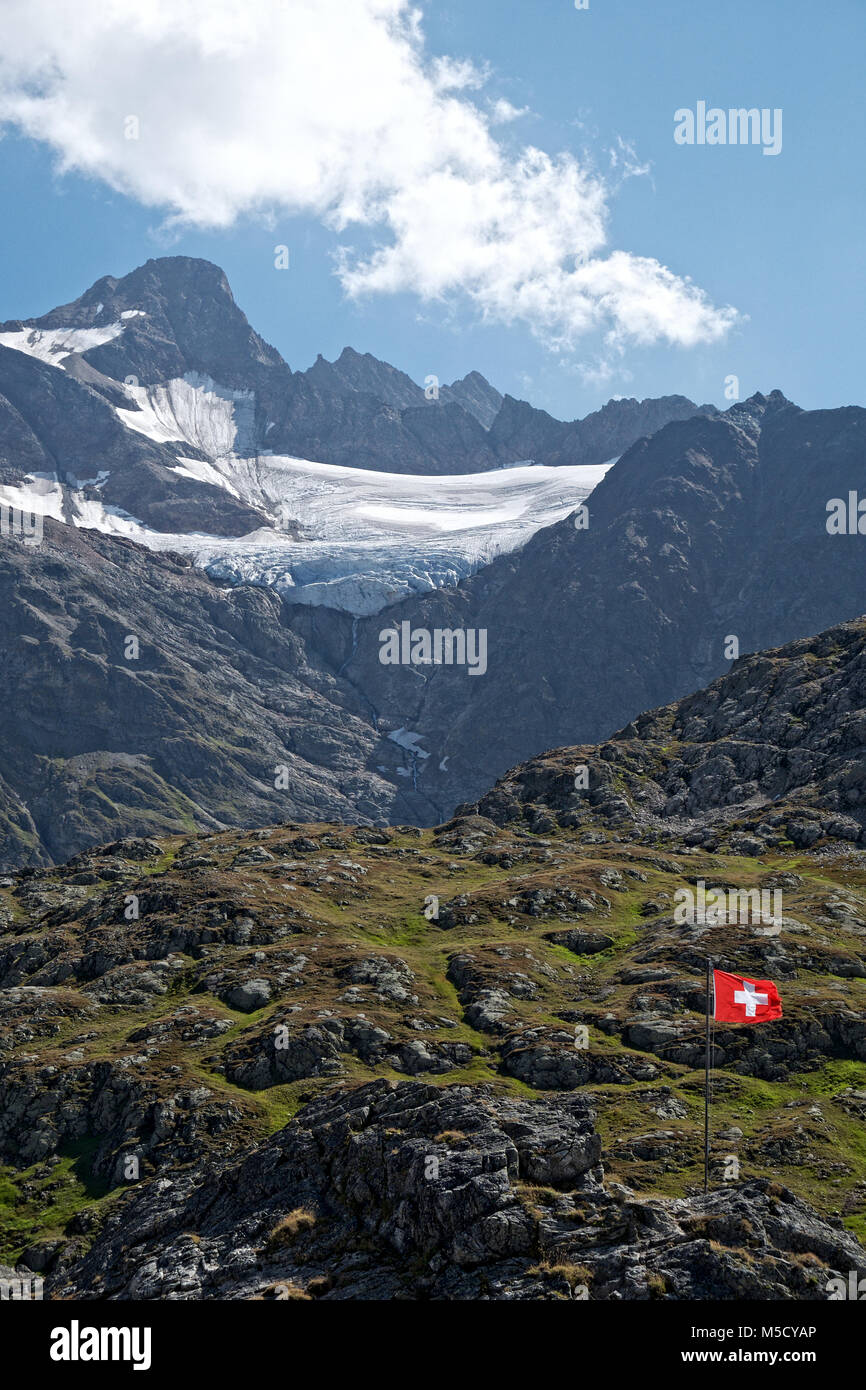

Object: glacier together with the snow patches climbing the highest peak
[0,339,616,617]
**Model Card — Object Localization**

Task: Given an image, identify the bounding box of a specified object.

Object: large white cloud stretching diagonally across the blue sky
[0,0,737,350]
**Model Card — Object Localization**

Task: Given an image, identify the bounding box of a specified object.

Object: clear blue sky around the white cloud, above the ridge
[0,0,866,418]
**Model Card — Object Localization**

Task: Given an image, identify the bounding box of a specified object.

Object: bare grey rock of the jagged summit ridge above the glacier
[0,256,706,478]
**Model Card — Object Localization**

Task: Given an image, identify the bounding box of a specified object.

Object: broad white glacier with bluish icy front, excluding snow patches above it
[0,455,613,617]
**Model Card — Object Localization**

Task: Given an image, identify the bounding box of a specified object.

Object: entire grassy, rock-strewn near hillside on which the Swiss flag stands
[0,621,866,1300]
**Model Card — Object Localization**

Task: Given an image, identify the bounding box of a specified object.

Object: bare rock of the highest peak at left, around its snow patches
[0,256,288,535]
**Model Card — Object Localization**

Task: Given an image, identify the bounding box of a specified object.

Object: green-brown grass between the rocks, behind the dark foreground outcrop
[0,827,866,1261]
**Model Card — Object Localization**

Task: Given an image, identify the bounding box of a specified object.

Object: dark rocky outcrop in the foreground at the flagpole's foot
[49,1081,866,1300]
